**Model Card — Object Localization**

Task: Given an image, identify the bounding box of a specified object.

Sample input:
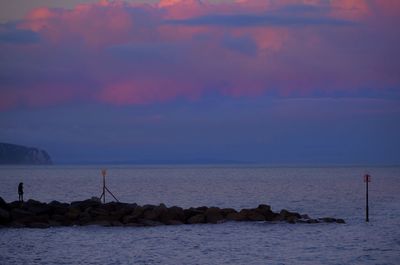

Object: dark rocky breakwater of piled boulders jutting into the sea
[0,197,345,228]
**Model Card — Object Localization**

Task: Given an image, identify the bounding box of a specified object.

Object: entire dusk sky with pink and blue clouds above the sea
[0,0,400,165]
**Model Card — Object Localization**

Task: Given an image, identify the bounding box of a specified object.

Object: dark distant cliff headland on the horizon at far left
[0,143,53,165]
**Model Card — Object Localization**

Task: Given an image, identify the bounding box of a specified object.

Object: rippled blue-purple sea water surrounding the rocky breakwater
[0,166,400,265]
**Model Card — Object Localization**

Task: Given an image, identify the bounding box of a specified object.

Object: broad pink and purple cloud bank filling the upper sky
[0,0,400,110]
